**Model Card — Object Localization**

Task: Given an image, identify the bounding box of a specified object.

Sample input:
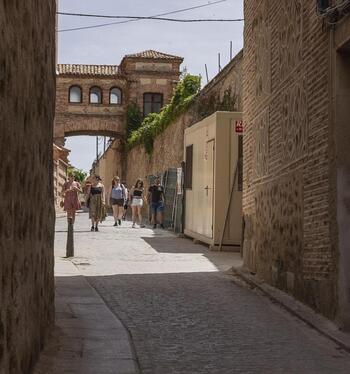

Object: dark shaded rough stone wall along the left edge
[0,0,56,374]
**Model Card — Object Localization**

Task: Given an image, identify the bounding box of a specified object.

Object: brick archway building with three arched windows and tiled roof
[54,51,183,144]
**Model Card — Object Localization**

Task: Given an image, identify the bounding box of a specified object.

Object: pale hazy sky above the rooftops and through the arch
[58,0,243,171]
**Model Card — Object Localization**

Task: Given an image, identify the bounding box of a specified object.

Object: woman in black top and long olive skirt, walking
[88,175,106,231]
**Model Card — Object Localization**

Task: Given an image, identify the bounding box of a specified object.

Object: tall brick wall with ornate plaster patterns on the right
[243,0,350,324]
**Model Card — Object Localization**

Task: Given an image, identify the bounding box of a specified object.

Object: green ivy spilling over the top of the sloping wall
[127,74,201,154]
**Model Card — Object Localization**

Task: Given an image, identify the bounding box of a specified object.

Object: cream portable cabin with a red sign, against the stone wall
[184,112,243,250]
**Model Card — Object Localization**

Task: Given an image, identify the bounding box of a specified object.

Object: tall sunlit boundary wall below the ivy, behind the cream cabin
[95,52,243,197]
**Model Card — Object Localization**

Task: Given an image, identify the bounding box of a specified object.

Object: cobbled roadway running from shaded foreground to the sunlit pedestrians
[56,215,350,374]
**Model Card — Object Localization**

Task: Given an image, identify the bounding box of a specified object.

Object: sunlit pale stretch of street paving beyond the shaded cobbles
[55,214,241,276]
